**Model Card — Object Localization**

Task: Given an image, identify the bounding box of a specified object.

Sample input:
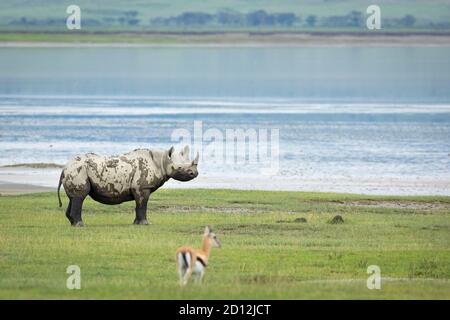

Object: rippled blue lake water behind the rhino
[0,46,450,194]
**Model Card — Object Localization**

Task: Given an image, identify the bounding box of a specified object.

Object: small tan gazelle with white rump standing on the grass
[176,227,222,287]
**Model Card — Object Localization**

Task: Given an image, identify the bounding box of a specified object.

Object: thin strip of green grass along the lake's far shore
[0,28,450,45]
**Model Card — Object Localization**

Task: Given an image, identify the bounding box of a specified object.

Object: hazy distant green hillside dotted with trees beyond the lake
[0,0,450,32]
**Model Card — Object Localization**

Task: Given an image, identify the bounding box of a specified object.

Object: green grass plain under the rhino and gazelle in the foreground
[0,189,450,299]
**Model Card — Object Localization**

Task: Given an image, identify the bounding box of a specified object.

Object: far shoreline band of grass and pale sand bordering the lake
[0,33,450,48]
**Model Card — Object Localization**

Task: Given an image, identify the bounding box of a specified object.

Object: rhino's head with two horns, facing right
[166,146,199,181]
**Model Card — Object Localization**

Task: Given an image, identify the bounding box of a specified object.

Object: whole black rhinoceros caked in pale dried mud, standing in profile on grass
[58,146,199,226]
